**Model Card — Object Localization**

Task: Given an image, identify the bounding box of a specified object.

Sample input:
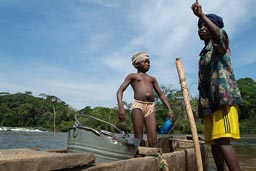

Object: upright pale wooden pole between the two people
[176,58,203,171]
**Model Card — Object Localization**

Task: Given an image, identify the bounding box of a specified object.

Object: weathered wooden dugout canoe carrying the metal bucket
[0,137,208,171]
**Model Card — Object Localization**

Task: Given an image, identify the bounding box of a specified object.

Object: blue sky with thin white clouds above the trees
[0,0,256,110]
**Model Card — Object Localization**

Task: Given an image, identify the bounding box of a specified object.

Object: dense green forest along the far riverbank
[0,78,256,134]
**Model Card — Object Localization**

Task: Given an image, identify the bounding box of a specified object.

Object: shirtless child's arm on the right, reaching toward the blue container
[153,78,174,123]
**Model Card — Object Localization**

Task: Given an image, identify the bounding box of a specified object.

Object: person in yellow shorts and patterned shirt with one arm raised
[191,3,241,171]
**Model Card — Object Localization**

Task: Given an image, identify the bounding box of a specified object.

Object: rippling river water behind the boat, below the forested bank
[0,131,256,171]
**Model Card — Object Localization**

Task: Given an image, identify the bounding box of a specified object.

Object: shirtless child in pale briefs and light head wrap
[117,52,174,147]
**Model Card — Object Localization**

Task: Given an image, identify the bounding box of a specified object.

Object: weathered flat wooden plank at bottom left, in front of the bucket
[0,149,95,171]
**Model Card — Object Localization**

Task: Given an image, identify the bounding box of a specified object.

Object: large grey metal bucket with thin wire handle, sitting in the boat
[67,115,139,163]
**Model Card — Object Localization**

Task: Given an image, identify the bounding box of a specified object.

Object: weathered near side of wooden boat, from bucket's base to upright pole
[82,148,200,171]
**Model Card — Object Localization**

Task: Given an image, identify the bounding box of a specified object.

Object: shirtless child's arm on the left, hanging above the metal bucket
[116,74,132,121]
